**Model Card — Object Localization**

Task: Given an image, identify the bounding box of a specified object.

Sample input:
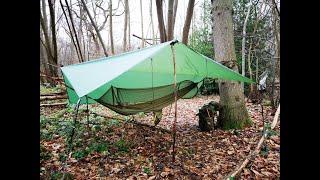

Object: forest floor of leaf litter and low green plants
[40,87,280,179]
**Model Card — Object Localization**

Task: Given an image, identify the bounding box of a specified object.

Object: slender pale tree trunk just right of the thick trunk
[241,0,252,92]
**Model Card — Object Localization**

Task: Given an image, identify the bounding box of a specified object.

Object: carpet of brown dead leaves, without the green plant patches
[41,96,280,179]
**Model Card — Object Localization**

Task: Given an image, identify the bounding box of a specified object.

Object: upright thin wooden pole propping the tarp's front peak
[171,44,177,162]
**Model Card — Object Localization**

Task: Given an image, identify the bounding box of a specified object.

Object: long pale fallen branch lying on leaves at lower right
[225,104,280,180]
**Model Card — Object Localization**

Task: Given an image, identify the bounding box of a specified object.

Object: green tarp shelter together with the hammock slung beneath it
[61,41,252,115]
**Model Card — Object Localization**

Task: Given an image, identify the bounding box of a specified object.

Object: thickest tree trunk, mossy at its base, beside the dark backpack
[212,0,251,129]
